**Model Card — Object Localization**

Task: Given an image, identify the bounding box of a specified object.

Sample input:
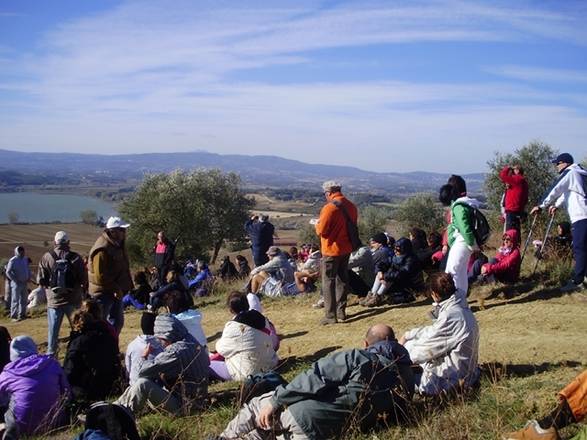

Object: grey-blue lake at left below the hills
[0,192,116,223]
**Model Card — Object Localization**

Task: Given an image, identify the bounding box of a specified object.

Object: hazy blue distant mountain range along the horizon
[0,150,485,194]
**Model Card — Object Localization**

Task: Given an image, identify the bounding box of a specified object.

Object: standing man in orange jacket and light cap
[316,180,358,325]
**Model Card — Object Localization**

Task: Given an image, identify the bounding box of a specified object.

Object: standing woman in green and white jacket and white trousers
[439,175,479,304]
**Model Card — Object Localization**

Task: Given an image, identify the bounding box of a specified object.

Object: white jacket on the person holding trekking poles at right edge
[540,164,587,223]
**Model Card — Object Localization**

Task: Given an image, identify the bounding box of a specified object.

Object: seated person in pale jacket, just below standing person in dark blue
[251,246,295,297]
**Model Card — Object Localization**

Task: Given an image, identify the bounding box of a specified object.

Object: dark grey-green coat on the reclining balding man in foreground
[271,341,411,439]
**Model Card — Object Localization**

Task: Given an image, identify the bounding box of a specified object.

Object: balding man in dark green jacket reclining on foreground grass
[216,324,413,439]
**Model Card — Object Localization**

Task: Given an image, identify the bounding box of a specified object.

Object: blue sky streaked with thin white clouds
[0,0,587,173]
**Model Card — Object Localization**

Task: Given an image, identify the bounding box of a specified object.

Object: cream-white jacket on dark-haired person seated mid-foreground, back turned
[216,321,279,381]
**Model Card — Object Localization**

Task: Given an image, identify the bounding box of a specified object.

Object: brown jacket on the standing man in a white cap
[88,232,133,297]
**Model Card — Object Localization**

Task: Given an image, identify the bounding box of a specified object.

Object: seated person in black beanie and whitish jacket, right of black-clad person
[124,312,163,385]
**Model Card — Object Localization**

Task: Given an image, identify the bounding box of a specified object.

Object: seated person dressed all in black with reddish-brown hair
[63,310,122,402]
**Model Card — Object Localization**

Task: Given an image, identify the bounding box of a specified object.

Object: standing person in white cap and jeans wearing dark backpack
[37,231,87,356]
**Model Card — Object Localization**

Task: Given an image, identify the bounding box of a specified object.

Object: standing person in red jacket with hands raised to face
[499,164,528,233]
